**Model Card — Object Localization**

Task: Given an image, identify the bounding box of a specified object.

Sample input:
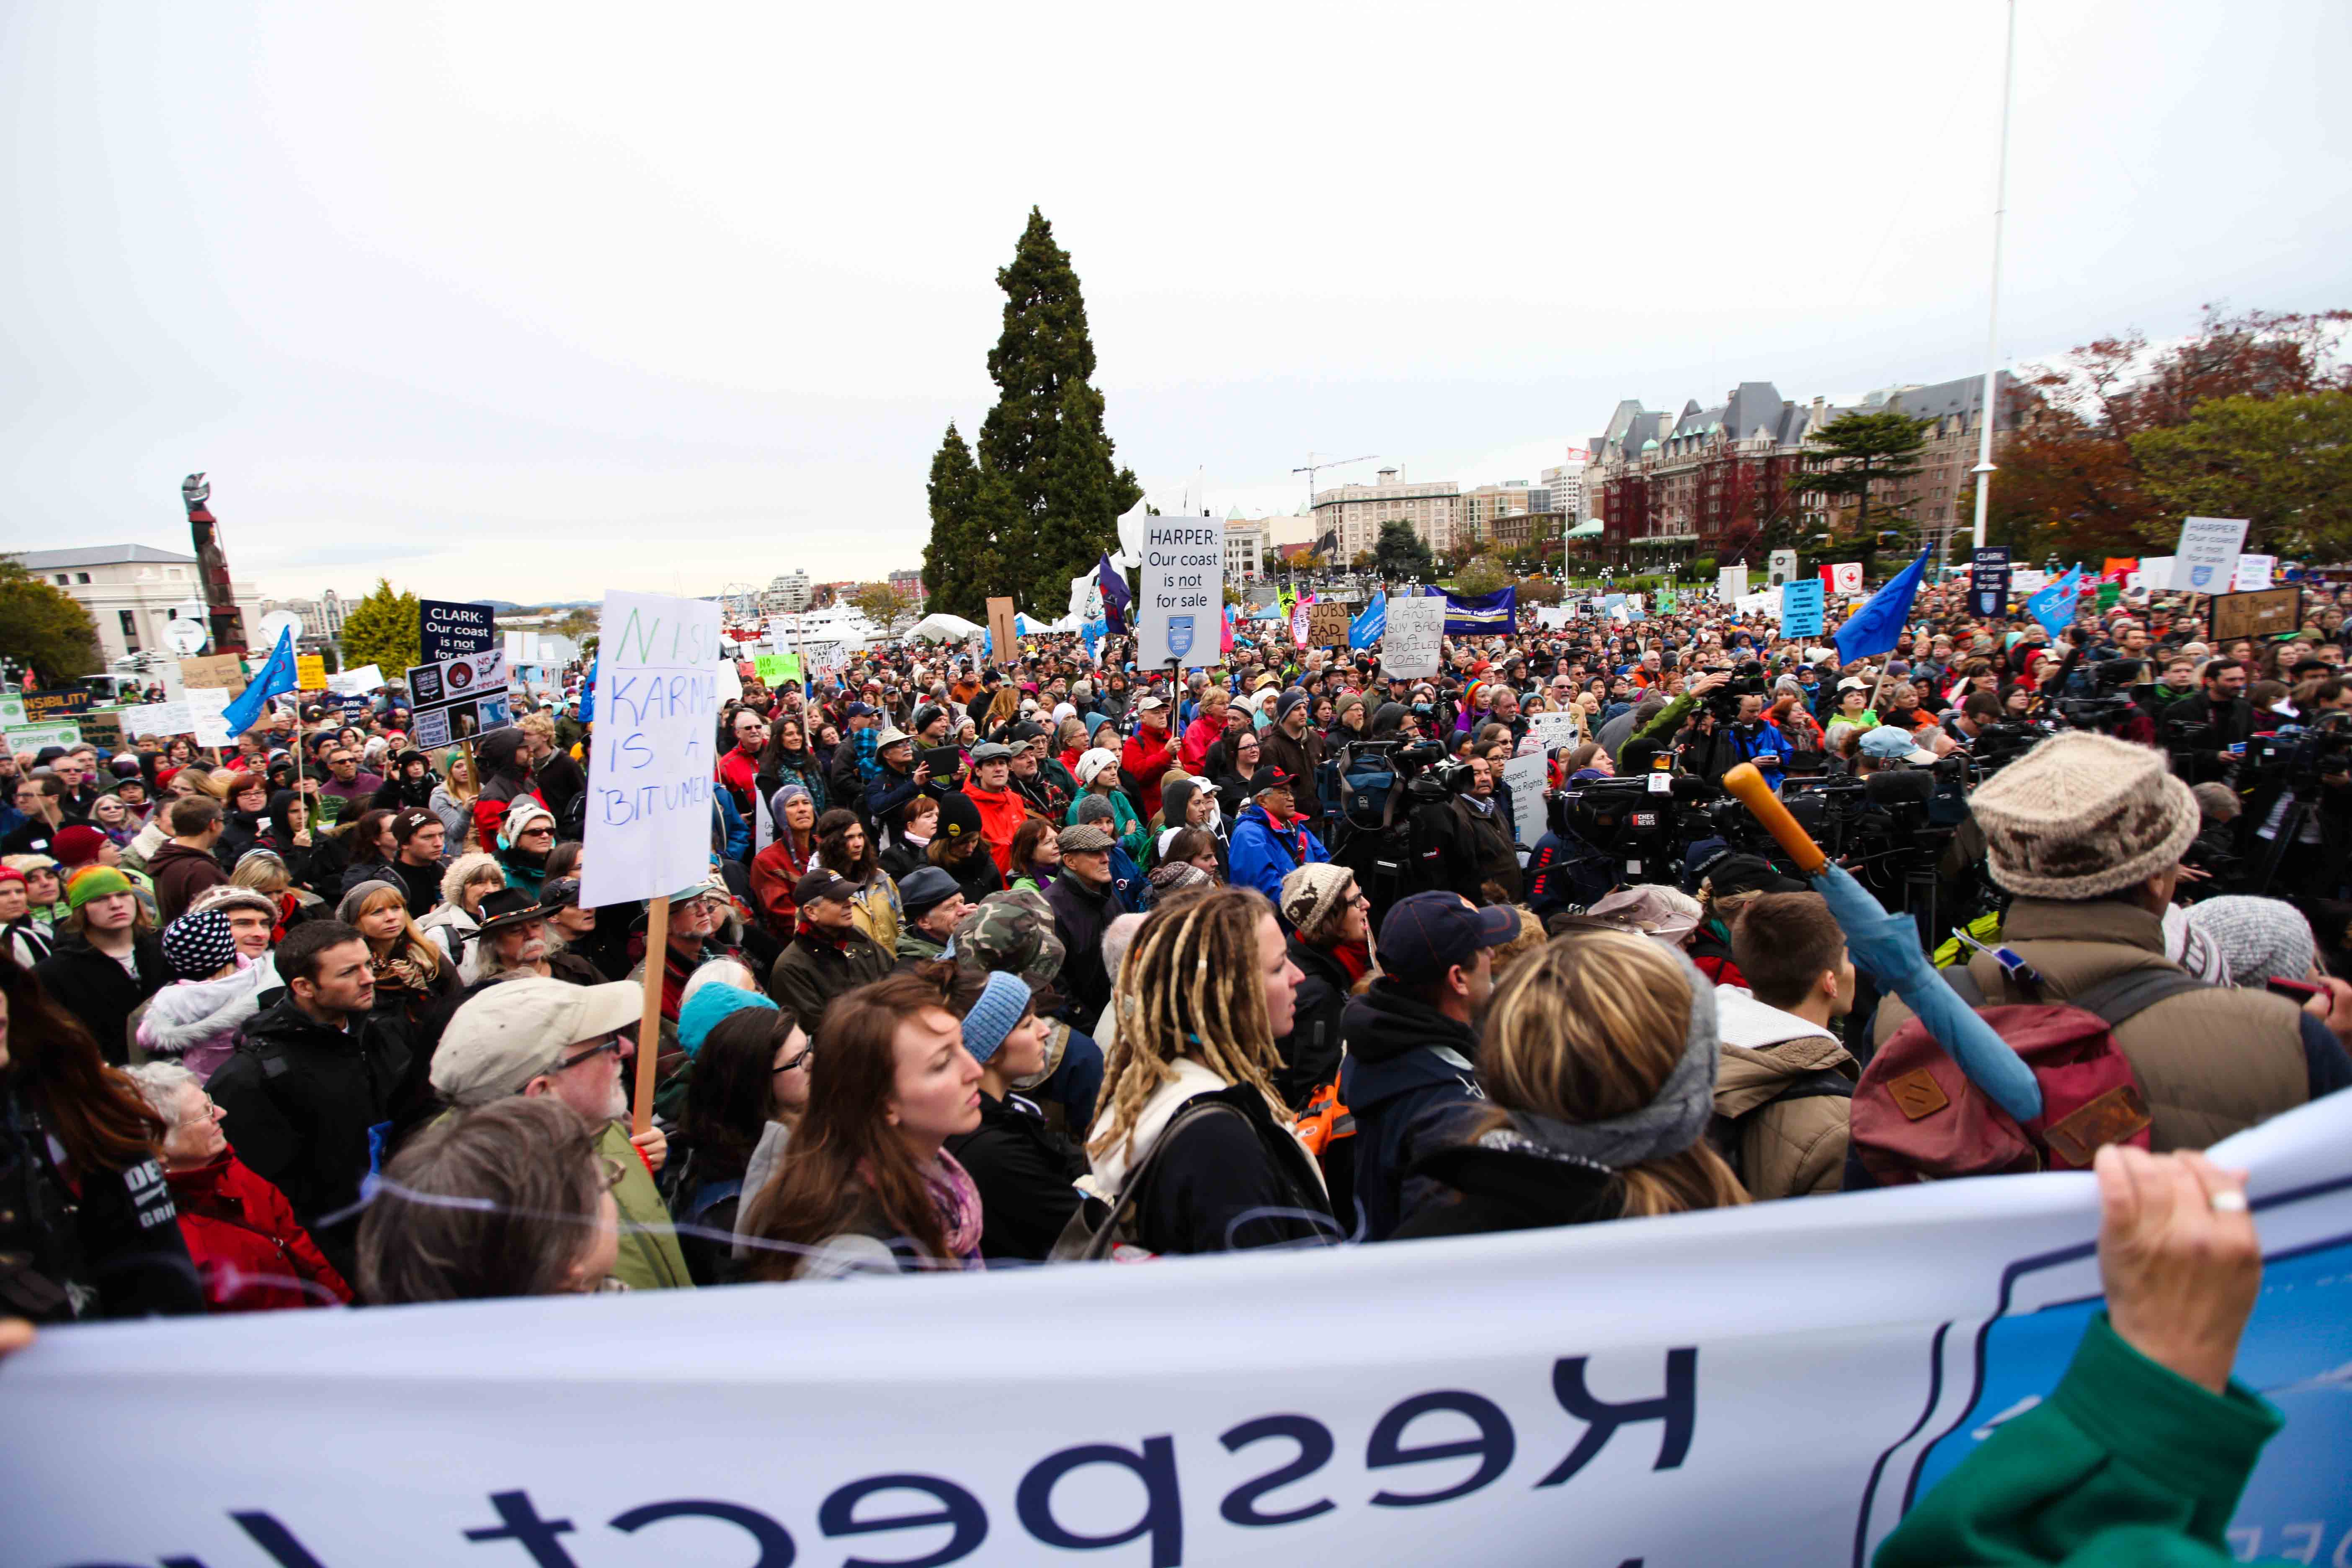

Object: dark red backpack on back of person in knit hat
[1851,966,2206,1185]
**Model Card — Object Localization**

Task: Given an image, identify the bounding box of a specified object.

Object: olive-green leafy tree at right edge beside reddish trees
[2131,392,2352,560]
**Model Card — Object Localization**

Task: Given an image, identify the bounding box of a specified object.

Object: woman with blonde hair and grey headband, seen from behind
[1395,931,1748,1239]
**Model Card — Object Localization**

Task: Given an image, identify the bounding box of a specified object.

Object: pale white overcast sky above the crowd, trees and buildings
[0,0,2352,614]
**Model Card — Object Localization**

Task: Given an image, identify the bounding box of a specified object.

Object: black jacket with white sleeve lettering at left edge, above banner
[0,1072,205,1323]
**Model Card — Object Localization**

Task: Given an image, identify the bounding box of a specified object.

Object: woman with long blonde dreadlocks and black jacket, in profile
[1089,886,1338,1253]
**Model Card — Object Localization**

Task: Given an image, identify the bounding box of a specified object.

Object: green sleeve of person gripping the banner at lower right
[1872,1312,2284,1568]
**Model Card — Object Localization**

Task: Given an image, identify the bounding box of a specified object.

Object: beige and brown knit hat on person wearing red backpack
[1969,731,2197,900]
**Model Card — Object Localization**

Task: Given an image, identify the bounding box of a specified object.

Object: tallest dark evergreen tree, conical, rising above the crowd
[978,207,1143,614]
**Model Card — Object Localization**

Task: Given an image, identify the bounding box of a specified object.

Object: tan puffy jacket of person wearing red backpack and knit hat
[1872,898,2312,1154]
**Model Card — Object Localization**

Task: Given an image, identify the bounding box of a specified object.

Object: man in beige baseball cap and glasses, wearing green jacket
[433,975,694,1291]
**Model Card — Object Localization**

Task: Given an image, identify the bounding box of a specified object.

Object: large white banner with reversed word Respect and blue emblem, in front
[13,1096,2352,1568]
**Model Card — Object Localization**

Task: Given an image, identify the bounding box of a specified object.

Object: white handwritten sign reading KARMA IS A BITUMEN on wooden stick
[581,588,720,908]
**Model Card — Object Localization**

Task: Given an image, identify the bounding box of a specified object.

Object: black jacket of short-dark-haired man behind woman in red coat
[205,997,414,1279]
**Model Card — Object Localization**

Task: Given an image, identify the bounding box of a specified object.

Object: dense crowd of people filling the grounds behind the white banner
[0,564,2352,1561]
